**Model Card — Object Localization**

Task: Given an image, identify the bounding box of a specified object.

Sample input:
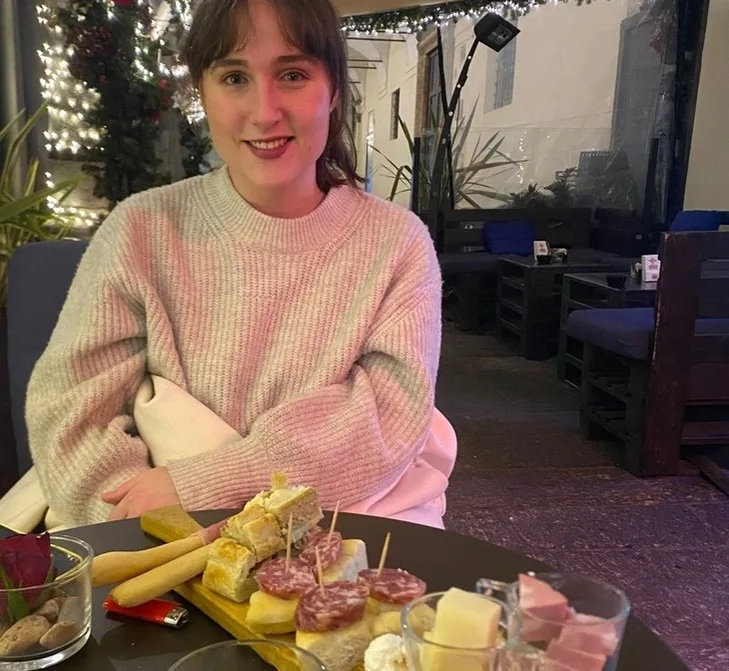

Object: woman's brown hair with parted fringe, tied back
[182,0,364,193]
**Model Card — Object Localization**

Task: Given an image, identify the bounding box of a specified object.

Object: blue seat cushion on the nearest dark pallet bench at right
[566,308,729,360]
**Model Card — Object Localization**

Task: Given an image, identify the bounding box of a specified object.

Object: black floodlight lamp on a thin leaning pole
[427,14,519,252]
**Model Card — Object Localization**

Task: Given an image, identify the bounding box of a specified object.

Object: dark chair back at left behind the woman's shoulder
[7,240,88,475]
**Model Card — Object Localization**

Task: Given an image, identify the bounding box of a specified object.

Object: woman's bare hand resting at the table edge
[101,467,180,522]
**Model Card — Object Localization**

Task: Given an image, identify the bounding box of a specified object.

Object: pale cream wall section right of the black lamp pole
[455,0,632,201]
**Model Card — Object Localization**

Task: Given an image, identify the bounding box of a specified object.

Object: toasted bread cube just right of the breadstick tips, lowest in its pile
[203,538,256,603]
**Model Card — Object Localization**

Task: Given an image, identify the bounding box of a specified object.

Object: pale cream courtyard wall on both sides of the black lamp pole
[359,0,636,205]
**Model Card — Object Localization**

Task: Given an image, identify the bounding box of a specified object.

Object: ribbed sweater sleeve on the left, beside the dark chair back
[26,207,149,524]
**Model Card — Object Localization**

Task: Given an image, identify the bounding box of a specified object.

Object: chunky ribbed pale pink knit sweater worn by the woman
[27,169,455,524]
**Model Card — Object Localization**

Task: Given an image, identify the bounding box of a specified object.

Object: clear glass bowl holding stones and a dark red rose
[0,534,94,671]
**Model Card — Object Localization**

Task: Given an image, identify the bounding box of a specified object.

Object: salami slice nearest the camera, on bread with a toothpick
[294,580,369,631]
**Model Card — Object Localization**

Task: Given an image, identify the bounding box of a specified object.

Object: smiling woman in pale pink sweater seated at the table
[27,0,455,526]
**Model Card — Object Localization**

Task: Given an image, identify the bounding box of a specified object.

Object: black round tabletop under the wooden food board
[56,511,689,671]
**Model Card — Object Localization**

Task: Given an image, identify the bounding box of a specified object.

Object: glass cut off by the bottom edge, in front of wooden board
[169,638,327,671]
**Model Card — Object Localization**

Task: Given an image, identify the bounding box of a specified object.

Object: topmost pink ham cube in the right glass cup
[519,574,569,643]
